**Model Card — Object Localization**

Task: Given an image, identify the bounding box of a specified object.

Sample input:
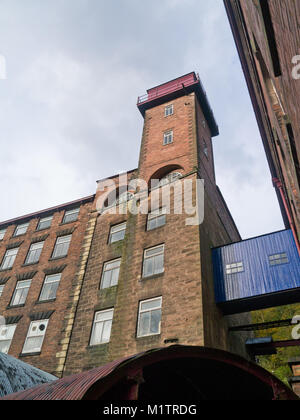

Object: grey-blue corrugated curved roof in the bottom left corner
[0,353,57,397]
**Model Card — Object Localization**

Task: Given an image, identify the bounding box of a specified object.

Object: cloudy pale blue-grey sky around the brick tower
[0,0,284,238]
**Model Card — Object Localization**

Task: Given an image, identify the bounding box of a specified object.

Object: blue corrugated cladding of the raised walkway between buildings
[213,230,300,303]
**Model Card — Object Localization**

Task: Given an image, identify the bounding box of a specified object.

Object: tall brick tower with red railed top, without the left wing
[64,73,251,375]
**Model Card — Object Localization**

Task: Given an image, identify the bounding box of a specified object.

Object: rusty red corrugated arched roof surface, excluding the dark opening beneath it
[4,345,297,400]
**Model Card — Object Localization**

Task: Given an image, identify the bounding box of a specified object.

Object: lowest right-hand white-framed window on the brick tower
[137,297,162,337]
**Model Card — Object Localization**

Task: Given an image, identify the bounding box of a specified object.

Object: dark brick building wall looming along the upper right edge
[224,0,300,250]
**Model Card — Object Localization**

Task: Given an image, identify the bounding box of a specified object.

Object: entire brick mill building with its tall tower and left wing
[0,73,252,376]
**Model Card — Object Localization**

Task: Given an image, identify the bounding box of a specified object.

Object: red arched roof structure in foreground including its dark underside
[5,345,298,401]
